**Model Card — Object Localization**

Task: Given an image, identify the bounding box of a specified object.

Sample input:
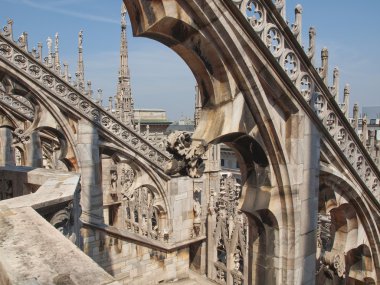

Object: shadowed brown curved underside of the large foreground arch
[125,8,232,107]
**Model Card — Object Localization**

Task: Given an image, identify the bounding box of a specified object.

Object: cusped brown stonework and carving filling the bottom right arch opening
[316,178,376,284]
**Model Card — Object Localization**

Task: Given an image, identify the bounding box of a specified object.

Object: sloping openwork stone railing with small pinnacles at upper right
[231,0,380,193]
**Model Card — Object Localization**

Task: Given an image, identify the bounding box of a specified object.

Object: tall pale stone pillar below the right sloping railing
[292,116,320,284]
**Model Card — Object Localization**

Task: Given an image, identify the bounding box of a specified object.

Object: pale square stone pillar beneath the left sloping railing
[77,121,104,224]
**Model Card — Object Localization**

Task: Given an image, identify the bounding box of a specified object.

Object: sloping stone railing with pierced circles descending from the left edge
[0,23,169,169]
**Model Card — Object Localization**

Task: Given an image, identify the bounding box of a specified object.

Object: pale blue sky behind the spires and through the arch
[0,0,380,120]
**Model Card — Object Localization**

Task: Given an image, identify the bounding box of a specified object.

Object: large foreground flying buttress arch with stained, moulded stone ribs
[124,0,303,283]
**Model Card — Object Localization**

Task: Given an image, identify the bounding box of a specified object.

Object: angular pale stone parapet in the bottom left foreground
[0,167,119,285]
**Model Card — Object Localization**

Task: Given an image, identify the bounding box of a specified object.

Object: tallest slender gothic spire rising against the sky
[115,3,134,125]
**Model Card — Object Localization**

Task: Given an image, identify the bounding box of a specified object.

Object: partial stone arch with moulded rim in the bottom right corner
[317,165,379,284]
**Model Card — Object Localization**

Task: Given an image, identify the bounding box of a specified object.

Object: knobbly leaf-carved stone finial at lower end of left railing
[165,131,207,178]
